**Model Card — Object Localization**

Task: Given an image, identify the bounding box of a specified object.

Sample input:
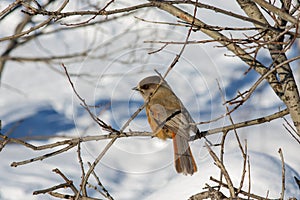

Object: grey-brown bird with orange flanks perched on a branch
[132,75,200,175]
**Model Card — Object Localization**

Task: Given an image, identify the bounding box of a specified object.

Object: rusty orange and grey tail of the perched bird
[172,133,197,175]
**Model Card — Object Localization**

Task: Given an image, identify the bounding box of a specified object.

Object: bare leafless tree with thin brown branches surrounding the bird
[0,0,300,199]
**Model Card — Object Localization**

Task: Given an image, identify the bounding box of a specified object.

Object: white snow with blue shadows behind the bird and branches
[0,0,300,200]
